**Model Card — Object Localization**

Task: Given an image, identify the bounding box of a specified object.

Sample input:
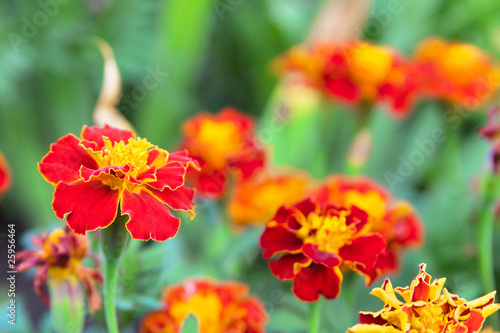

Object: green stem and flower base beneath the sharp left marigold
[101,210,130,333]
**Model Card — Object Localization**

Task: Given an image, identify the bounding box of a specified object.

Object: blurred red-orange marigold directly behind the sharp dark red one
[315,177,423,285]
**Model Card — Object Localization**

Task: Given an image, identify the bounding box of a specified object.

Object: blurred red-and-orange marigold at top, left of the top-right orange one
[277,41,420,116]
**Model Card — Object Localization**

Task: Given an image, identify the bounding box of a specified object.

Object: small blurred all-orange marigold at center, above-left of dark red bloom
[227,173,308,226]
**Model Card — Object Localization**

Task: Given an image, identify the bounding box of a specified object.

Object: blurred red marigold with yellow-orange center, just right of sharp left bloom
[182,108,265,198]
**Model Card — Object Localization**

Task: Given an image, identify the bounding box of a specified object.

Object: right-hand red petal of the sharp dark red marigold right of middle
[339,234,386,269]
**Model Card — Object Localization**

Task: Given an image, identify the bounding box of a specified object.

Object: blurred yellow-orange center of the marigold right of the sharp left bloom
[193,119,242,169]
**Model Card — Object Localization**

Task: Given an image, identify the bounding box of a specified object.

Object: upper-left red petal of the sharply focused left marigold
[38,134,99,185]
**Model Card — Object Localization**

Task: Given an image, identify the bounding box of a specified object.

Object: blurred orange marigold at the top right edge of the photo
[416,37,500,107]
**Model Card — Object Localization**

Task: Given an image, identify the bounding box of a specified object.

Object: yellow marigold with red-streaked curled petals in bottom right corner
[347,264,500,333]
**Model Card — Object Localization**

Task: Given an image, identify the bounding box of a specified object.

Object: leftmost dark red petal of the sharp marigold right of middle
[260,226,302,259]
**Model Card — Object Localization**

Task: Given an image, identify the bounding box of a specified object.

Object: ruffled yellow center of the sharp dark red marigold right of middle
[297,211,356,254]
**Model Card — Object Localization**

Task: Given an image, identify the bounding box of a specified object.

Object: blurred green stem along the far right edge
[478,173,500,328]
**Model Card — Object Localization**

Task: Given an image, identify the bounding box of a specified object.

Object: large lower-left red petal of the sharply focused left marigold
[52,179,120,235]
